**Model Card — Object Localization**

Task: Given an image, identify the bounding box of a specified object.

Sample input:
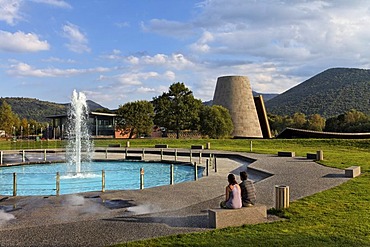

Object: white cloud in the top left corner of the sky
[0,0,22,25]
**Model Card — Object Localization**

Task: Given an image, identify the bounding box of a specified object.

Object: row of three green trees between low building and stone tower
[117,82,234,138]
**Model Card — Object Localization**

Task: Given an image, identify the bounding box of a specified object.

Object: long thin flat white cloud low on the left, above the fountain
[7,63,111,77]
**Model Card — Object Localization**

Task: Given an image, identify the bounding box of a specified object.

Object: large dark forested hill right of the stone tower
[266,68,370,118]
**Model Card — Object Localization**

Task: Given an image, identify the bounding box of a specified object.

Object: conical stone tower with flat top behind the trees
[213,76,263,138]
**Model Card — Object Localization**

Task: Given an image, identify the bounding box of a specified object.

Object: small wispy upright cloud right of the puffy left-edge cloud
[62,23,91,53]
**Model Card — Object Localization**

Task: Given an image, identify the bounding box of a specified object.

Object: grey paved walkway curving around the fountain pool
[0,152,348,246]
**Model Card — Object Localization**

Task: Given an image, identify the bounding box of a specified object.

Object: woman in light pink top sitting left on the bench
[220,174,242,208]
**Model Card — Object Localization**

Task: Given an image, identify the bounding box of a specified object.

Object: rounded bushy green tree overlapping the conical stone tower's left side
[200,105,234,139]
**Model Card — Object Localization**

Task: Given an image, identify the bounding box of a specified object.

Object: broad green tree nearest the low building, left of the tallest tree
[116,100,154,139]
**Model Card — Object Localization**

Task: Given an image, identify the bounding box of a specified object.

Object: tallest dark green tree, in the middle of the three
[153,82,202,139]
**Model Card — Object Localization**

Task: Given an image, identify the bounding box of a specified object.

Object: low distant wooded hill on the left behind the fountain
[0,97,106,122]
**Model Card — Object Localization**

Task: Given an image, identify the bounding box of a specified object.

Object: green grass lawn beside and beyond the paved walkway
[0,139,370,246]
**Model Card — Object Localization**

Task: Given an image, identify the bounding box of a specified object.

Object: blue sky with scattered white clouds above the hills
[0,0,370,109]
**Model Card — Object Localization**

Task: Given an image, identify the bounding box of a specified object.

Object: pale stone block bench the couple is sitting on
[208,205,267,228]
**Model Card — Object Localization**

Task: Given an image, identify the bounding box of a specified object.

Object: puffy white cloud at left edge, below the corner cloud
[0,30,50,52]
